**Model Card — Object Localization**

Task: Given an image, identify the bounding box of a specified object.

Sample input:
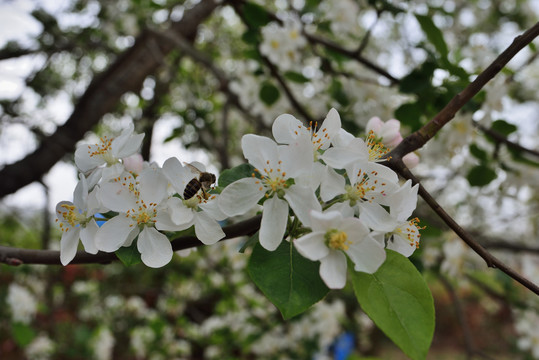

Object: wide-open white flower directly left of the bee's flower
[95,168,181,267]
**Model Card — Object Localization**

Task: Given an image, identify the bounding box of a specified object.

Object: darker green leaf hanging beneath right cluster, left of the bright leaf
[247,241,329,319]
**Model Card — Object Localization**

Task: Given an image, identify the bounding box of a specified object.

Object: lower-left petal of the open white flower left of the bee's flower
[95,214,137,252]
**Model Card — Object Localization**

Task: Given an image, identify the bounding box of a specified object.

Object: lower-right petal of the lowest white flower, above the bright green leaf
[346,236,386,274]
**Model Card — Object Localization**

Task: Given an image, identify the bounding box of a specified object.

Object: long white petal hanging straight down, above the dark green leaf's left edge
[259,196,288,251]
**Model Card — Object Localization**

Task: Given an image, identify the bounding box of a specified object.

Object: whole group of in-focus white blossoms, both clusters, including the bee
[56,109,420,289]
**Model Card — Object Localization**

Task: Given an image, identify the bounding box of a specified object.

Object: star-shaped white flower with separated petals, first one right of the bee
[219,134,321,251]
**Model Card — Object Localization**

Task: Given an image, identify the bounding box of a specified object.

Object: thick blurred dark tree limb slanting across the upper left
[0,0,218,198]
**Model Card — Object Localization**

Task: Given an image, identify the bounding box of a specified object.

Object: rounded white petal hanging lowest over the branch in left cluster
[137,227,174,268]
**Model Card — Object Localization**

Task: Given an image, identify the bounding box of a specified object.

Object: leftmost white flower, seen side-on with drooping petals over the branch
[56,174,100,265]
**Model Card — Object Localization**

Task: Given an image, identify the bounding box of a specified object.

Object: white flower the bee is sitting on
[163,158,226,245]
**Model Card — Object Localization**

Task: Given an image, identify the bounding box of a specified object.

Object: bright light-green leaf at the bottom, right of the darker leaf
[351,250,434,360]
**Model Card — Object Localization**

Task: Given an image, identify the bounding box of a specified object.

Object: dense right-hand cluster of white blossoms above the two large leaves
[219,109,420,289]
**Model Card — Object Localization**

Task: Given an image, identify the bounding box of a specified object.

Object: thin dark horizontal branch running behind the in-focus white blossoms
[0,215,262,266]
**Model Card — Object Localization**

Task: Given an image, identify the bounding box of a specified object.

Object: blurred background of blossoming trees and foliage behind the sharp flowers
[0,0,539,359]
